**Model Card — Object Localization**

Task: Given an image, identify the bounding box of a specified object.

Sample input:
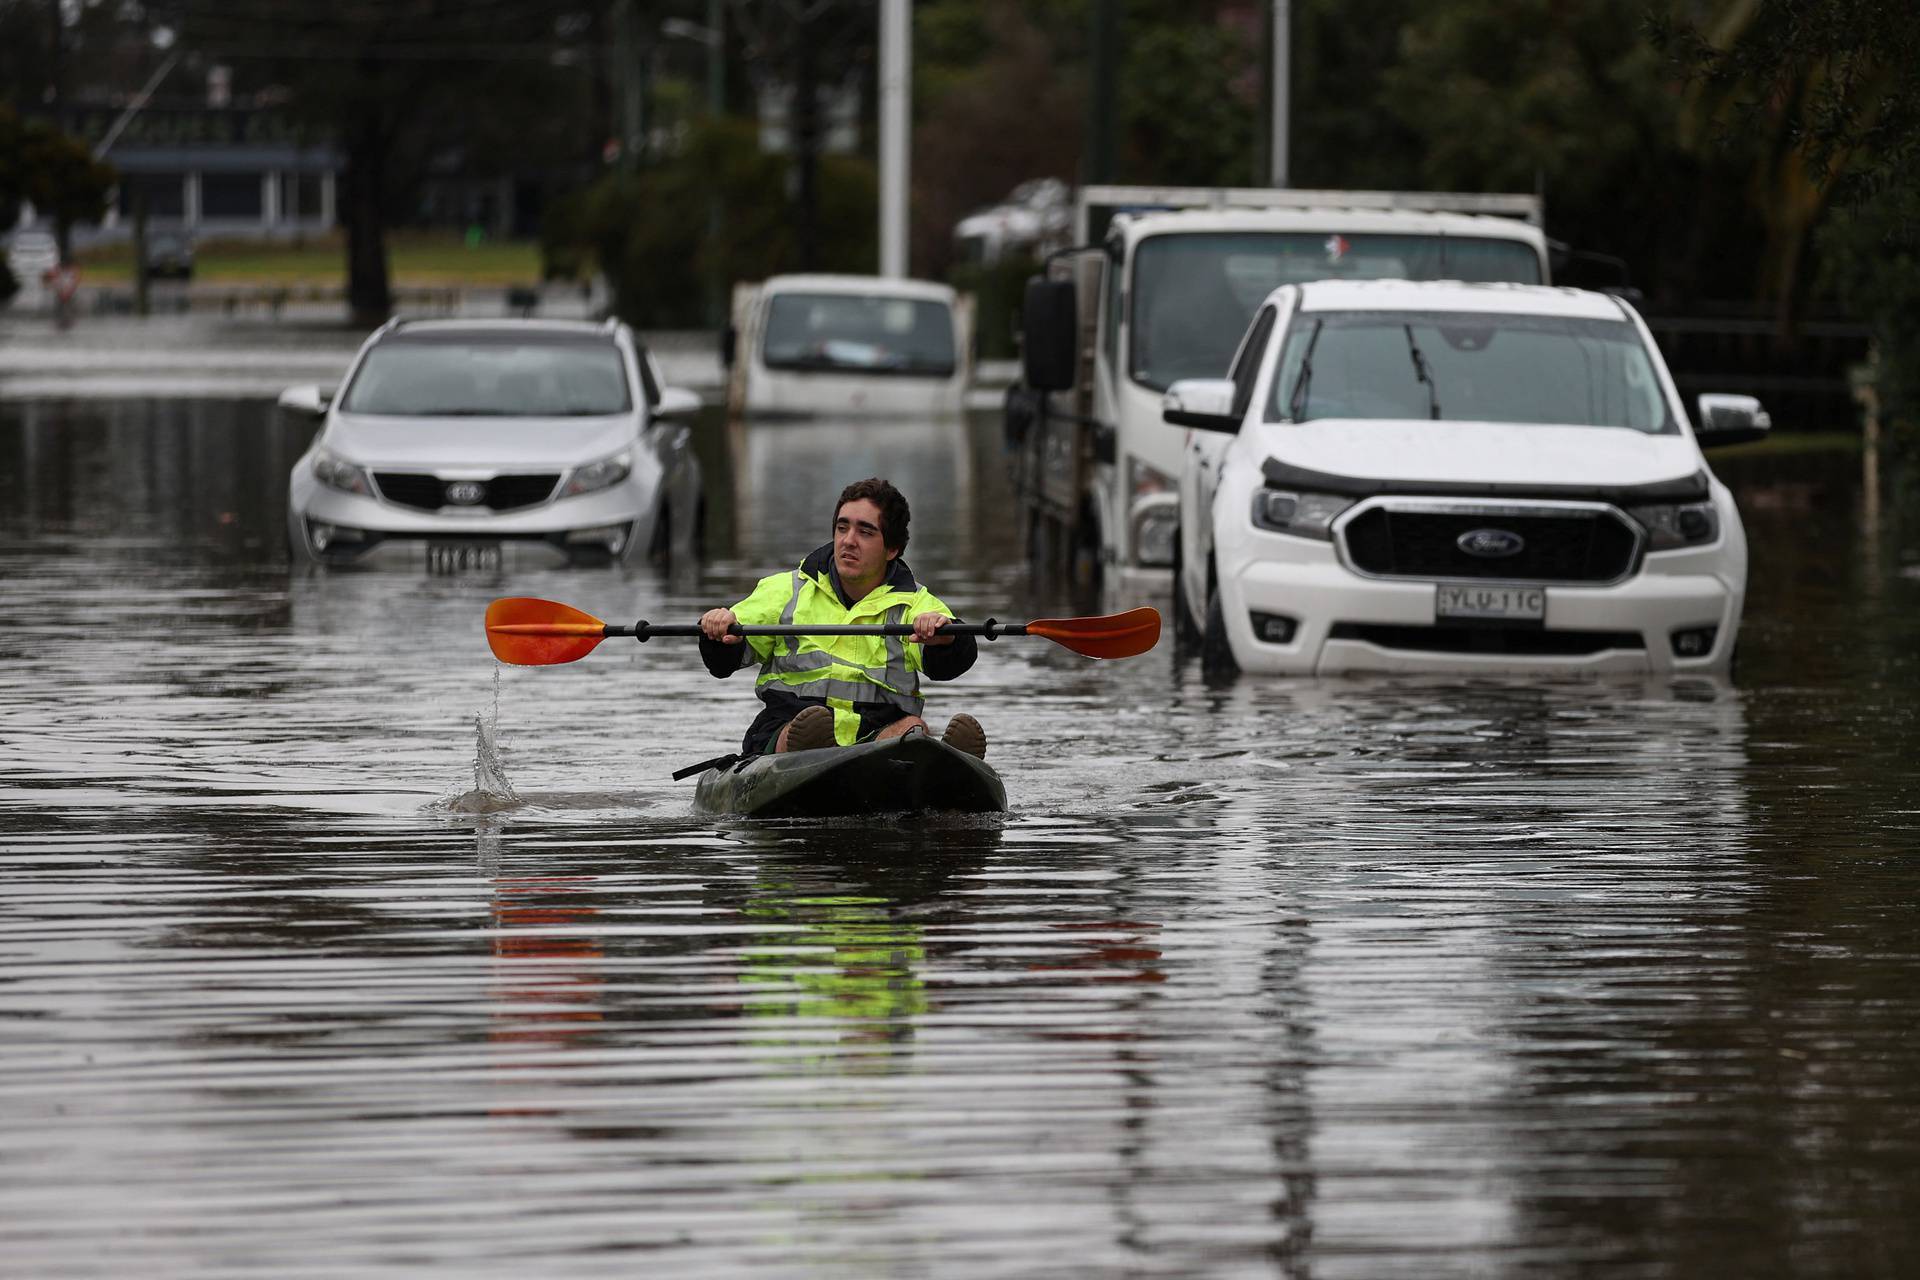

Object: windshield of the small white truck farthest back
[760,294,954,378]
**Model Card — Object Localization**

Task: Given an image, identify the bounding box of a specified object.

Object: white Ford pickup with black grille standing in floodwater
[1165,282,1766,674]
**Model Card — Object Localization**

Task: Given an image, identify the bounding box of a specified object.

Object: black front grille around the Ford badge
[1340,499,1640,581]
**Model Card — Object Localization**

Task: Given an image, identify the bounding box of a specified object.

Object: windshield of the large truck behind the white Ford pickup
[1129,232,1542,391]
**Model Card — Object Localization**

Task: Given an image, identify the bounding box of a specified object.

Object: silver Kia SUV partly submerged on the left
[280,320,701,568]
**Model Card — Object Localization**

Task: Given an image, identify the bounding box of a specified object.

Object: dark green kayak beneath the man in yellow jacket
[693,731,1006,818]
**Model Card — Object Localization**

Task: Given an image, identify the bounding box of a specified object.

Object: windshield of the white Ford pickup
[1267,311,1680,436]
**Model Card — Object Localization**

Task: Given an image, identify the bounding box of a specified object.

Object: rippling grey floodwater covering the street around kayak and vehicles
[0,399,1920,1278]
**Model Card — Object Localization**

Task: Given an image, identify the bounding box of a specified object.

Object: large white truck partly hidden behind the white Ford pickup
[1006,186,1551,585]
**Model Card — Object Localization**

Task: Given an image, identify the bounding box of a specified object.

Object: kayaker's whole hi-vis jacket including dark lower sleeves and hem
[701,543,977,756]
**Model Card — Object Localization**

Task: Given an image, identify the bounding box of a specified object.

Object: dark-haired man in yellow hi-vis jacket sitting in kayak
[701,478,987,758]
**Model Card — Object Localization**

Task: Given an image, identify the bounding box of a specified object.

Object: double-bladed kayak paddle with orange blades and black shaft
[486,595,1160,666]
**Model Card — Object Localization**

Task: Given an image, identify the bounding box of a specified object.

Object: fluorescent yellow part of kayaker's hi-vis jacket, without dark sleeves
[733,543,952,747]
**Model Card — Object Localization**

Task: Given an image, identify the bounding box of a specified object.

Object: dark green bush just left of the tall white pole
[560,117,879,328]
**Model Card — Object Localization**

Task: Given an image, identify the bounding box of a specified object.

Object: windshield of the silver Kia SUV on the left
[340,332,634,418]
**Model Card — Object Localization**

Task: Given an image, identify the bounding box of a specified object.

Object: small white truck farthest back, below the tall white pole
[728,276,972,416]
